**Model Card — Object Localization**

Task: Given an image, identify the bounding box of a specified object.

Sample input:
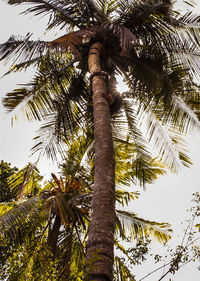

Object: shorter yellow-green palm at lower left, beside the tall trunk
[0,164,91,280]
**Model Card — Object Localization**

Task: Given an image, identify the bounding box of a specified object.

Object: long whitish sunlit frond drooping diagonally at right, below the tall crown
[135,92,195,168]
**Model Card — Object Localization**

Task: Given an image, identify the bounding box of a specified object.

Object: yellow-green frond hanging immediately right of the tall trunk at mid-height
[112,98,165,187]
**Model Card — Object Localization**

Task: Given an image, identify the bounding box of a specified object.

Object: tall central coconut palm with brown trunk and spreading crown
[1,0,200,280]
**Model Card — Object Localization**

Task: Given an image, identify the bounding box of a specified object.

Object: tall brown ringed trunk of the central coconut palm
[86,42,115,281]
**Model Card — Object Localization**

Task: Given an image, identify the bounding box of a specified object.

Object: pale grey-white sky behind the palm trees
[0,1,200,281]
